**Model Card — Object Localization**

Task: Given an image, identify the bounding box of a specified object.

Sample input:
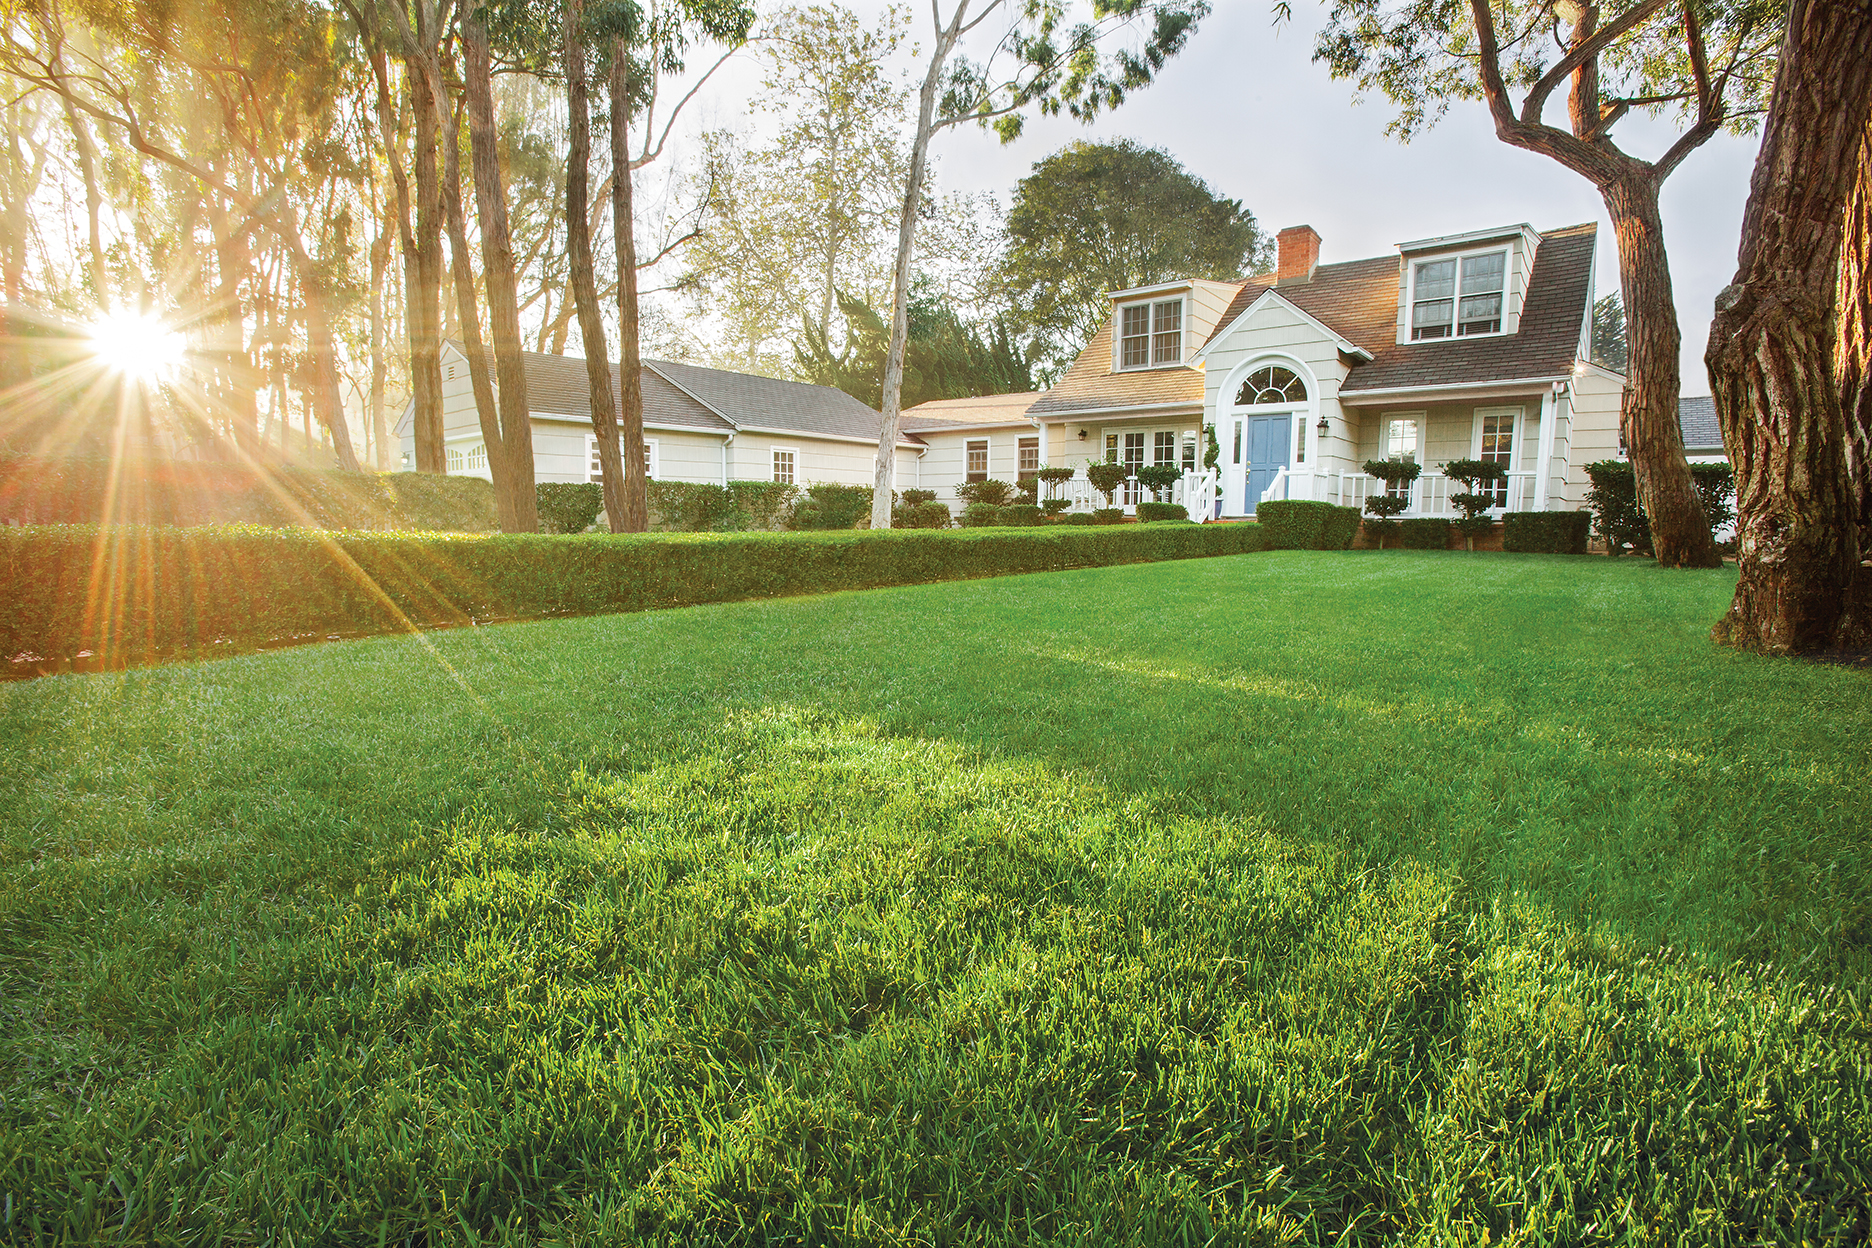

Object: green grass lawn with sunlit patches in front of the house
[0,552,1872,1244]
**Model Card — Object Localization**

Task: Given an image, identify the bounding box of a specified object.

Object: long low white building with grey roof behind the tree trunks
[397,342,923,488]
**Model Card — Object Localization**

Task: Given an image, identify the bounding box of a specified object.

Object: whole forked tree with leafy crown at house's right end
[1314,0,1782,567]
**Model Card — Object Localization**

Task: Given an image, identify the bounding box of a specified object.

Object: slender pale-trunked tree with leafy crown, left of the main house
[870,0,1209,530]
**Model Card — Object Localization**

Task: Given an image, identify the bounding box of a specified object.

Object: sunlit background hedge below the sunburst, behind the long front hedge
[0,455,496,533]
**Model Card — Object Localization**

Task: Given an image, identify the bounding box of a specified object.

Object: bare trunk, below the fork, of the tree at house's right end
[1602,168,1722,567]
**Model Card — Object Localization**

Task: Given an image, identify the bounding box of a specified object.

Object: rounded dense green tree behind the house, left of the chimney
[1003,138,1271,374]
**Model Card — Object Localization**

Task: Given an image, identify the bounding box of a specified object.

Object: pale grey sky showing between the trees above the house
[695,0,1758,395]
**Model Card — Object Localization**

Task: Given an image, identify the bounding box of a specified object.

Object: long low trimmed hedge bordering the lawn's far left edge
[0,524,1265,670]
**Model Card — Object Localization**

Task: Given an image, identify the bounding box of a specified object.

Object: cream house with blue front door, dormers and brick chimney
[904,225,1625,518]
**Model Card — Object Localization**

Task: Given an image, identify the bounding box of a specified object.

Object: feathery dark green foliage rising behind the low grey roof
[794,284,1035,408]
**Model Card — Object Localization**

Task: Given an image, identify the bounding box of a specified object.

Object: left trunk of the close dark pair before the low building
[565,0,625,533]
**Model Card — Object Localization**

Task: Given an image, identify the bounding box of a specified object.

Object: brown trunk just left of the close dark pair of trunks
[462,15,539,533]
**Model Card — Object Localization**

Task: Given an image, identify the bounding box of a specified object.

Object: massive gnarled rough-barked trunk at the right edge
[1704,0,1872,653]
